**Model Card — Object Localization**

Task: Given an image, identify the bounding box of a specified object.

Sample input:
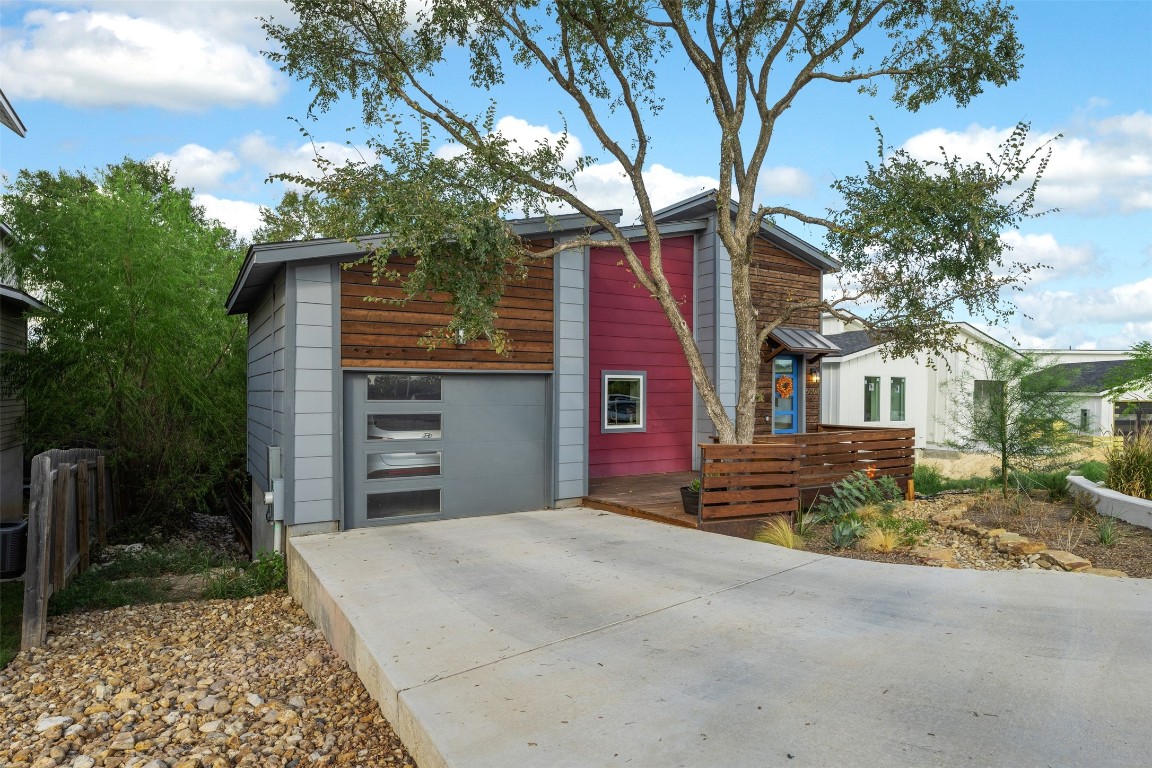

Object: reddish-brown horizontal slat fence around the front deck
[698,425,916,532]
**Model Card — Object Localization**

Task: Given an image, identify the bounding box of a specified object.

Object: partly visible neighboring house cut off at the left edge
[0,91,35,523]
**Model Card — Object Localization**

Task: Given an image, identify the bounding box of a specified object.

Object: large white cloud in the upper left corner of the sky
[0,3,287,111]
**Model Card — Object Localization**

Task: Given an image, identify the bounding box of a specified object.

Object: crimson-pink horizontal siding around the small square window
[588,236,694,478]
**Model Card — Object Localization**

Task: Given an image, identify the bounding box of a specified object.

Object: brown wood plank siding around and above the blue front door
[751,239,821,439]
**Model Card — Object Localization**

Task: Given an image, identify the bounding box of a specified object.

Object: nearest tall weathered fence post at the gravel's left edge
[20,454,54,651]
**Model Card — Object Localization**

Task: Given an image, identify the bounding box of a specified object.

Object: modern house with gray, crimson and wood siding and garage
[227,192,839,549]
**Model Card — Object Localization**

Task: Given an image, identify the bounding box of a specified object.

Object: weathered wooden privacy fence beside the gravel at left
[21,448,120,648]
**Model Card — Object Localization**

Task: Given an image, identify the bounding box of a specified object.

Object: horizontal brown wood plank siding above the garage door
[340,251,555,371]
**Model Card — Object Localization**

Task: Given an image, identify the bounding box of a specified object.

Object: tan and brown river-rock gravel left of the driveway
[0,592,415,768]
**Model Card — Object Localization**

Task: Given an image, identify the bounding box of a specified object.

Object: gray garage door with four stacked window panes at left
[344,373,550,527]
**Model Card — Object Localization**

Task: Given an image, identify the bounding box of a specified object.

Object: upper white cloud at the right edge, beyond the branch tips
[904,112,1152,214]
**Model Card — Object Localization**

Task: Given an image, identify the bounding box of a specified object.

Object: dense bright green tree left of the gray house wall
[0,159,247,514]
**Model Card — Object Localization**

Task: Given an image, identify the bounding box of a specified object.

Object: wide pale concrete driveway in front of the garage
[289,509,1152,768]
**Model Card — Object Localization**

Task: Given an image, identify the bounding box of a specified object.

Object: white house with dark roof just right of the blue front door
[820,317,1007,448]
